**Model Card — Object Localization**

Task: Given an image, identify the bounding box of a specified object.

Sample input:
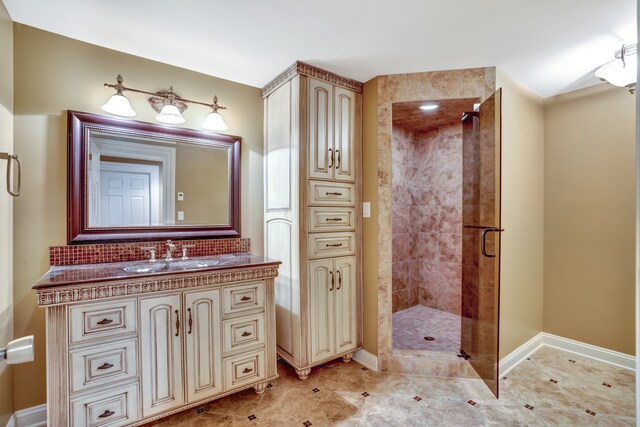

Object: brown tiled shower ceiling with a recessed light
[391,98,480,132]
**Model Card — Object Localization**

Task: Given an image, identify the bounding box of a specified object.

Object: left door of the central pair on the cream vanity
[140,295,184,417]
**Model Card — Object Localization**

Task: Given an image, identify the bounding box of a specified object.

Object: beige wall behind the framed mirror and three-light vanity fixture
[13,24,263,409]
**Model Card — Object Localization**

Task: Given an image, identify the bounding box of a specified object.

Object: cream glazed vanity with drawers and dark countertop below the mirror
[34,254,279,426]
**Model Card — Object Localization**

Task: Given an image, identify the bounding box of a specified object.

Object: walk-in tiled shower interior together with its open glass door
[392,91,501,395]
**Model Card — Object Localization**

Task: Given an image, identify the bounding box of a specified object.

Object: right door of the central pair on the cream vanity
[184,289,222,402]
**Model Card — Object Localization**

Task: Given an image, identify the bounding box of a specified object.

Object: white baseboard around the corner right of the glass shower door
[498,332,636,376]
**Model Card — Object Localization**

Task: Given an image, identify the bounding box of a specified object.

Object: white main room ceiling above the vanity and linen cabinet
[2,0,637,97]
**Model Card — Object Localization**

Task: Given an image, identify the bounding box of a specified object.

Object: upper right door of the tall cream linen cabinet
[333,87,356,182]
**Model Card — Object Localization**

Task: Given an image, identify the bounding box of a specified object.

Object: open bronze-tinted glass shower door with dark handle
[460,89,503,397]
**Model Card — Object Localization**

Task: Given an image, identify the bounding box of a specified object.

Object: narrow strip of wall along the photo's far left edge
[0,1,13,425]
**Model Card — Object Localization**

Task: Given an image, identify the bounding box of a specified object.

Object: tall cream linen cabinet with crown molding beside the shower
[263,62,362,379]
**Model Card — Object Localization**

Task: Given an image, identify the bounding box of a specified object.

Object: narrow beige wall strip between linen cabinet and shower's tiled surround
[362,77,378,354]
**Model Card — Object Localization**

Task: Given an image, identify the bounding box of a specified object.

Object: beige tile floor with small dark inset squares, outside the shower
[149,347,635,427]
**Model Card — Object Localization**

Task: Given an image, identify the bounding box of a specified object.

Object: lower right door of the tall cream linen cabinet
[335,257,358,353]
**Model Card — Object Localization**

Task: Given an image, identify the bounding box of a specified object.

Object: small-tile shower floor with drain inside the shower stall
[393,305,461,352]
